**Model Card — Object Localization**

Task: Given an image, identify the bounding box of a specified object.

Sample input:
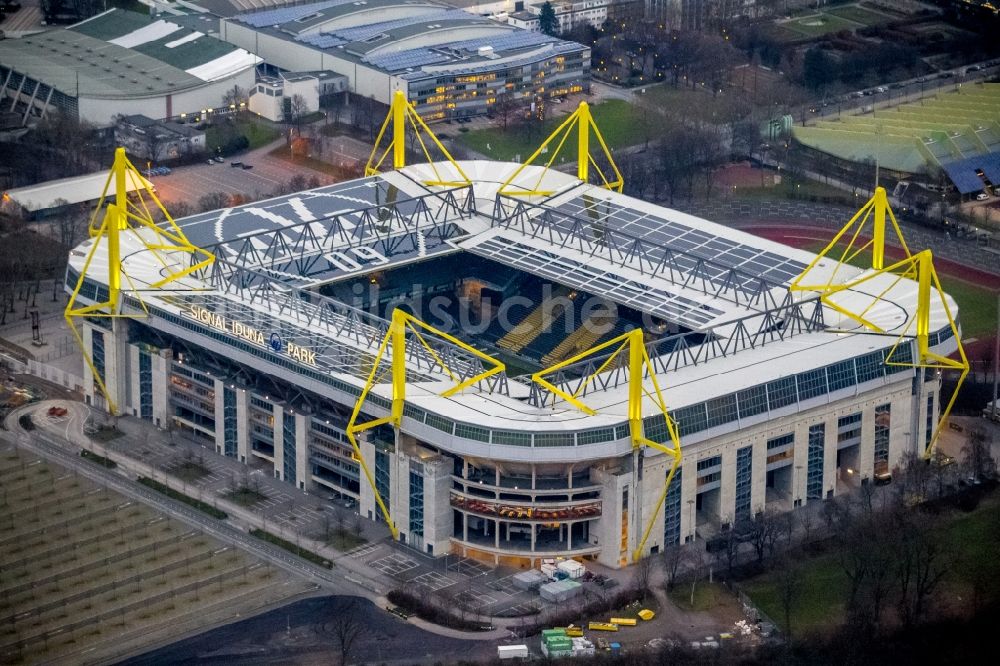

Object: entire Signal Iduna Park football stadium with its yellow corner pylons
[66,94,968,567]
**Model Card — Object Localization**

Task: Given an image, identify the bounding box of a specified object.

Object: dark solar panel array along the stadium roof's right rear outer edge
[552,197,806,288]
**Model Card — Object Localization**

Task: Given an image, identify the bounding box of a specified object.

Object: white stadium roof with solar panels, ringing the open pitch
[70,161,956,460]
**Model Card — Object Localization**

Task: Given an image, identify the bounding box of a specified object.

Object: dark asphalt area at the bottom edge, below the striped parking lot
[122,596,496,666]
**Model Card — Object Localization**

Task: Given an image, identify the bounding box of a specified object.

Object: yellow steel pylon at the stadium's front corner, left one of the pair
[346,308,506,539]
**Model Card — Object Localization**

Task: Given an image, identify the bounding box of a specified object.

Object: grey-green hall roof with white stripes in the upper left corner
[0,9,260,98]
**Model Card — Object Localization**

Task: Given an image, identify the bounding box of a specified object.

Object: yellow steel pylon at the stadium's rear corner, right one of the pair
[500,102,625,197]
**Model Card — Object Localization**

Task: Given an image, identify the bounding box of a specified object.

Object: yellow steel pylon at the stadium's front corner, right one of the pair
[531,328,681,562]
